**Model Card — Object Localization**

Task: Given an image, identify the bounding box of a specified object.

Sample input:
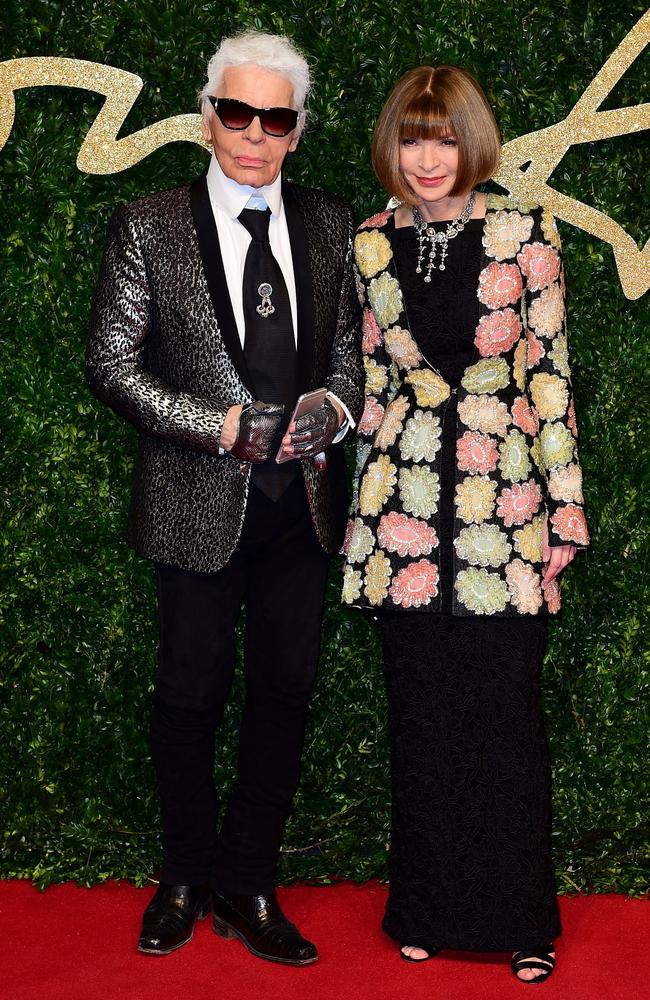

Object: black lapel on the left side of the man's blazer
[190,174,255,395]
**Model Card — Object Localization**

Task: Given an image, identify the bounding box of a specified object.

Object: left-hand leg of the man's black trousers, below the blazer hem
[150,557,245,885]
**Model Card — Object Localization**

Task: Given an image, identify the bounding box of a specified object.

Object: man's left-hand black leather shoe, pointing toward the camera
[138,882,210,955]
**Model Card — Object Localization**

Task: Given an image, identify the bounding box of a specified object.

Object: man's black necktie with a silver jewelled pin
[239,208,298,500]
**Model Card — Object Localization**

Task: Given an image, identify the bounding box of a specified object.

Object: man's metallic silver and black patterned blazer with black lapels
[86,175,363,572]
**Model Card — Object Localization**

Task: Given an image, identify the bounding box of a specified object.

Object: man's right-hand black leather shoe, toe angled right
[212,892,318,965]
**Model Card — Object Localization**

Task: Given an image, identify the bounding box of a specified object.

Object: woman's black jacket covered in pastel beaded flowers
[343,195,589,617]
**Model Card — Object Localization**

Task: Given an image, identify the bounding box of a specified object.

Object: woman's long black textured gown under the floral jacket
[378,220,560,951]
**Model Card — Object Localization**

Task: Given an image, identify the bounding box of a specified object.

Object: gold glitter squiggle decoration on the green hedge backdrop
[0,10,650,299]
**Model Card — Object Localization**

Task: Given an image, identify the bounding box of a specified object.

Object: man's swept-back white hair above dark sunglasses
[199,31,311,128]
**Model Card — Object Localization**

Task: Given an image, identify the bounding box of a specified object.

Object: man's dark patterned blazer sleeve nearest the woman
[325,205,363,423]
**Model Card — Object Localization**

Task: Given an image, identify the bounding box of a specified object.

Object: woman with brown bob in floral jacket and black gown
[343,66,589,983]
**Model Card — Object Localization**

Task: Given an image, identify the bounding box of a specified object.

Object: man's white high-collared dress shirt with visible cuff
[207,153,355,443]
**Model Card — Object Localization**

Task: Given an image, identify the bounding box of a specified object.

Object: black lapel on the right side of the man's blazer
[282,184,314,394]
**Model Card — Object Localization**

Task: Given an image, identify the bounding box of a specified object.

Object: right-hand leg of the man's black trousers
[213,479,329,893]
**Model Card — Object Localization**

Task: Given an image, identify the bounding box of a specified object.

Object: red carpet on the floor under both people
[0,881,650,1000]
